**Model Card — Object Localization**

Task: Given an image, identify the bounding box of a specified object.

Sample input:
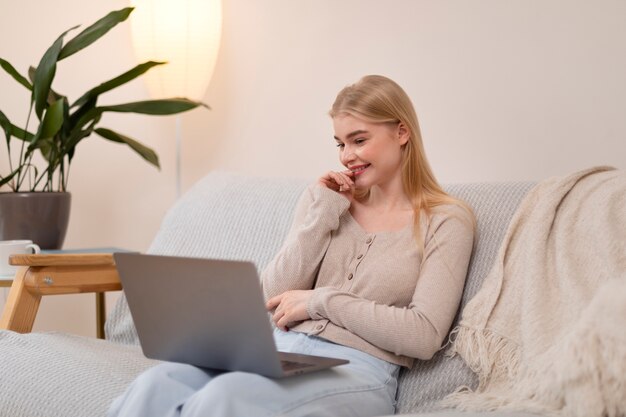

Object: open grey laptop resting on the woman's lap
[113,253,348,378]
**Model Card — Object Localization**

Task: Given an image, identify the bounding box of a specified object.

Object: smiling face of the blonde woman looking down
[333,114,409,188]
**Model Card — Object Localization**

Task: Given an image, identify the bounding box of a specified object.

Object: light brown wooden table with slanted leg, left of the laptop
[0,253,122,333]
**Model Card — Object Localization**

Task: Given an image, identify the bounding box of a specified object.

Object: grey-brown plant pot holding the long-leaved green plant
[0,192,71,249]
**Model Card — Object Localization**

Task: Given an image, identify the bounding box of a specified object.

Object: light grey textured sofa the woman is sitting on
[0,172,533,417]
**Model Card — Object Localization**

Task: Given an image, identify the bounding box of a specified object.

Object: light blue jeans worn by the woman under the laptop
[108,330,400,417]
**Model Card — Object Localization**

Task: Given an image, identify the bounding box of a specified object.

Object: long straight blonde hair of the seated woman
[329,75,475,251]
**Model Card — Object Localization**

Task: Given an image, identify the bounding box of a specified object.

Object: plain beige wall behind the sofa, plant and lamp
[0,0,626,335]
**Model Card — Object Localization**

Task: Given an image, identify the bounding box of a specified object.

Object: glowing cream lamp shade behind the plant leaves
[131,0,222,101]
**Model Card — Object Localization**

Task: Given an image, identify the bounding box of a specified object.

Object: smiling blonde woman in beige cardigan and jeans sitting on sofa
[110,76,474,417]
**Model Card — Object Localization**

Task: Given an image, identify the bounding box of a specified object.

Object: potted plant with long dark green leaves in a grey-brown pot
[0,7,208,249]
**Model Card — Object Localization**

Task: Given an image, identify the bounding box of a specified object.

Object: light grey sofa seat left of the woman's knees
[0,330,158,417]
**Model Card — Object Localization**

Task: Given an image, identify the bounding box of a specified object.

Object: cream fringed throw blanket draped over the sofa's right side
[443,167,626,417]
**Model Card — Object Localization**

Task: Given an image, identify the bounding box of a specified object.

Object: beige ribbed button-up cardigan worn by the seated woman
[262,185,474,368]
